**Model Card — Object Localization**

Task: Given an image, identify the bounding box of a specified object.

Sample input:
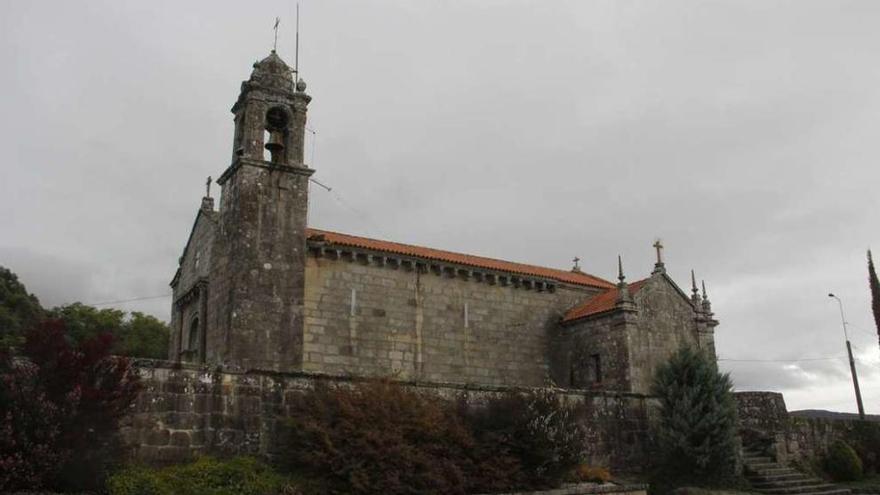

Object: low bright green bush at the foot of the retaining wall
[107,457,288,495]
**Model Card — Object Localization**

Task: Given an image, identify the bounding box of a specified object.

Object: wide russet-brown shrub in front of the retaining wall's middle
[282,380,473,495]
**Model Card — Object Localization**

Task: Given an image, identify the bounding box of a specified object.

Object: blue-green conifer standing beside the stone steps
[651,347,736,481]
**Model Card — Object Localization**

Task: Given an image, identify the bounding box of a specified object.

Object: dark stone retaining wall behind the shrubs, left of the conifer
[122,360,654,472]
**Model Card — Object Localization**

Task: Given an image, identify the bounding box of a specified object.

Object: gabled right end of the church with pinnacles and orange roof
[552,261,717,393]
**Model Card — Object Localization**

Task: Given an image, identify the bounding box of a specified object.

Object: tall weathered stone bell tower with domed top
[206,50,314,371]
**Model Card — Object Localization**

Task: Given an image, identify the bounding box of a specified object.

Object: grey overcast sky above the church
[0,0,880,413]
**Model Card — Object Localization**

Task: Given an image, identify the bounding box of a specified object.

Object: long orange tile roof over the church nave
[306,228,614,289]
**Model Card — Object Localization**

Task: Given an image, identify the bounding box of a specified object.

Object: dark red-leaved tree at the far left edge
[0,320,140,491]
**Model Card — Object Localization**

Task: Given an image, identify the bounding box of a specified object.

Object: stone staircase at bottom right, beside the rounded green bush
[743,448,851,495]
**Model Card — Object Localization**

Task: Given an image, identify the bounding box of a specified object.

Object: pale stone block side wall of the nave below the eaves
[303,255,595,386]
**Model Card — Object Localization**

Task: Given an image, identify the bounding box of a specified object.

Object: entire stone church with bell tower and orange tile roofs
[169,51,718,393]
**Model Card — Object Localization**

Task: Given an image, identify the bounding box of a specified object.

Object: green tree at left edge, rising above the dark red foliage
[0,266,43,347]
